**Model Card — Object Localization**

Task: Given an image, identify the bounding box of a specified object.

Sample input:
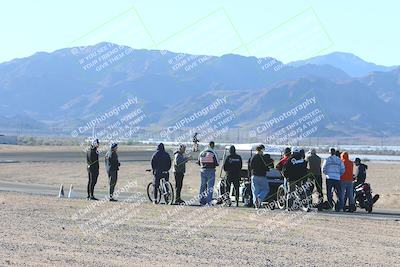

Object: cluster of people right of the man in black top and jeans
[277,148,368,212]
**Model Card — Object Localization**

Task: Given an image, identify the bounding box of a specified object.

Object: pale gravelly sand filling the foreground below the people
[0,193,400,266]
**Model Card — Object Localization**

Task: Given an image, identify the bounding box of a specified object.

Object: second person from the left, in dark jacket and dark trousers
[105,143,121,201]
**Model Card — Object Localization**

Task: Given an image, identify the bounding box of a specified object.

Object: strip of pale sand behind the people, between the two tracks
[0,159,400,209]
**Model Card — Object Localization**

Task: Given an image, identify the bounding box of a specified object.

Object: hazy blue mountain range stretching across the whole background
[0,43,400,139]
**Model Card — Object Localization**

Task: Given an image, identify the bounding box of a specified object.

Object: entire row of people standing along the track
[87,139,368,212]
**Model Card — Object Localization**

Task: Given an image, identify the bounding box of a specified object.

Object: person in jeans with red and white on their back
[197,141,219,206]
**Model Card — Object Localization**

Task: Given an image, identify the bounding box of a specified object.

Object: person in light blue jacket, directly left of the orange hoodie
[322,148,345,211]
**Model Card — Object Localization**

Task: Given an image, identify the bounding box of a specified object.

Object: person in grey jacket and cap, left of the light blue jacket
[306,148,324,211]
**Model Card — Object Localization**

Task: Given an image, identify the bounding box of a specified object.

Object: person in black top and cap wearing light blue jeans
[249,145,271,209]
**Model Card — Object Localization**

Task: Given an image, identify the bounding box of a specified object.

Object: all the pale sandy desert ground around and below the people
[0,146,400,266]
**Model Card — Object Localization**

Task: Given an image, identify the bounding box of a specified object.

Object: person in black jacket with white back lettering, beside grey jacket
[282,148,308,210]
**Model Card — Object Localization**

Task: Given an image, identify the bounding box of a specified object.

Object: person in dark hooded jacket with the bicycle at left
[151,143,171,203]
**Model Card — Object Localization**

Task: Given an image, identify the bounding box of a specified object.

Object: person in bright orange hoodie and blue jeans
[340,151,355,212]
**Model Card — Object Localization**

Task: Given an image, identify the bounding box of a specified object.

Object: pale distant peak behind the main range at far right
[290,52,398,77]
